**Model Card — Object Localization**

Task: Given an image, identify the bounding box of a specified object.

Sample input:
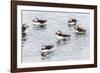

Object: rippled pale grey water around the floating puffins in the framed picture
[21,10,90,63]
